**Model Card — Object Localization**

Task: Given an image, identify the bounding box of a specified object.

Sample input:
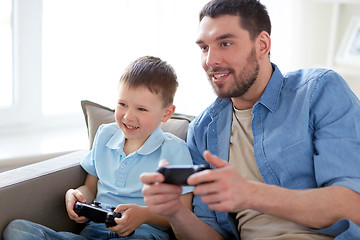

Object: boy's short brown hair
[119,56,179,107]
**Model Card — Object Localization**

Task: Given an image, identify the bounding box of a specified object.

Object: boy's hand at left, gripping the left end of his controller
[65,189,89,223]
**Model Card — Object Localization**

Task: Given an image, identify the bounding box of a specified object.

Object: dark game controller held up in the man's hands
[157,164,210,186]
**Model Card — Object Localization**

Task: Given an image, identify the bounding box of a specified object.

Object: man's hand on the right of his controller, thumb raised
[188,151,254,212]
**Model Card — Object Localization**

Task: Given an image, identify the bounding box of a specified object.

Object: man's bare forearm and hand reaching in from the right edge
[188,151,360,229]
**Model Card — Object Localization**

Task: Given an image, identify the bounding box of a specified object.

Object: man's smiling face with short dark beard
[197,15,259,98]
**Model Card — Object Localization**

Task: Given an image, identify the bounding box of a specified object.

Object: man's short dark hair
[199,0,271,40]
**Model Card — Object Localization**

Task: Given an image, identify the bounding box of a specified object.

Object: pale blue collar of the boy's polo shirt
[106,125,165,155]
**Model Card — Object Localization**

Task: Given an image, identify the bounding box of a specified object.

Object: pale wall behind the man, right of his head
[262,0,360,98]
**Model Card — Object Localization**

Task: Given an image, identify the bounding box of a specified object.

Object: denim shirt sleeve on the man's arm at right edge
[310,71,360,193]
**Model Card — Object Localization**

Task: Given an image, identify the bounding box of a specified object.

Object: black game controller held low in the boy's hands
[74,201,121,228]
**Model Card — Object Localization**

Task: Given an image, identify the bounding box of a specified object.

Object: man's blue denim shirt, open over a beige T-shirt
[187,64,360,239]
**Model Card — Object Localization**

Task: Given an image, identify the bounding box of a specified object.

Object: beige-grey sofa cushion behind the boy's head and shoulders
[81,100,194,149]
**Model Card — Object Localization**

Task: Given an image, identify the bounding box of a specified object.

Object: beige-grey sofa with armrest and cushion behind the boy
[0,101,193,235]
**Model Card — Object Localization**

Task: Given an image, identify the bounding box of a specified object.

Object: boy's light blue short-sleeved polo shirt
[81,123,193,207]
